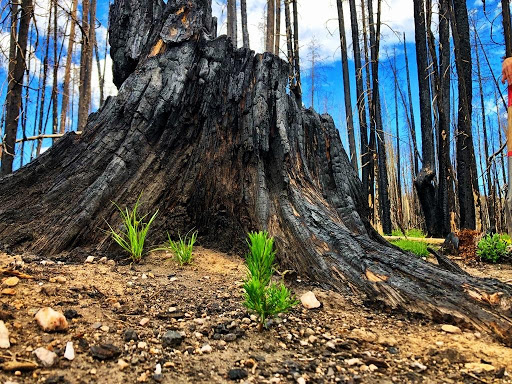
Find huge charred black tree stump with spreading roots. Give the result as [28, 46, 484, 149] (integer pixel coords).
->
[0, 0, 512, 344]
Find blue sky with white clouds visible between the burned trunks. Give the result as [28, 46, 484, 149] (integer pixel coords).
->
[0, 0, 505, 194]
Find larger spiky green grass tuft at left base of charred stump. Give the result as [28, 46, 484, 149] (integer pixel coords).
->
[107, 196, 158, 262]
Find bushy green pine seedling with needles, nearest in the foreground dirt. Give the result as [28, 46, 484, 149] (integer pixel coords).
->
[243, 232, 298, 331]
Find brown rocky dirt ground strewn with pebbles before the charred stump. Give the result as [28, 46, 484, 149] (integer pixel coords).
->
[0, 249, 512, 383]
